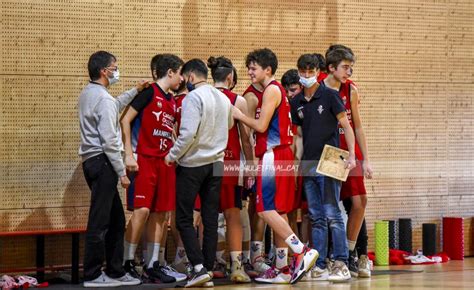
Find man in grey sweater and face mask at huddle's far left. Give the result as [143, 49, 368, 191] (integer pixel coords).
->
[78, 51, 148, 287]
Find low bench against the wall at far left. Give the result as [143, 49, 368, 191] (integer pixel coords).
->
[0, 229, 86, 284]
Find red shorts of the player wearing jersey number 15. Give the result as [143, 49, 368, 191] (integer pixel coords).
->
[127, 154, 176, 212]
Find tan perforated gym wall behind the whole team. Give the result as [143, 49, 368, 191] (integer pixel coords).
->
[0, 0, 474, 270]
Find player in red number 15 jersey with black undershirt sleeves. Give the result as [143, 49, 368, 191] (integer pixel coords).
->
[121, 54, 186, 283]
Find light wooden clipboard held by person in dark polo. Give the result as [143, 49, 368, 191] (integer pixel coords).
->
[316, 144, 350, 181]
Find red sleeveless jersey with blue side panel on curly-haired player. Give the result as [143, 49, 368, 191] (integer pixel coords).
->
[255, 80, 293, 157]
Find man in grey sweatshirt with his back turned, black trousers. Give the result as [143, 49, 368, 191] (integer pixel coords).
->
[165, 59, 233, 287]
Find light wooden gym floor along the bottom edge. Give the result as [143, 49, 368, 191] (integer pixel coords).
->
[50, 258, 474, 290]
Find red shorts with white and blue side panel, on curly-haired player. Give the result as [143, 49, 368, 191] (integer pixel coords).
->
[256, 146, 295, 213]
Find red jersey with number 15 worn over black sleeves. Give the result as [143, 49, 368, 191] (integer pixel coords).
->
[137, 83, 176, 157]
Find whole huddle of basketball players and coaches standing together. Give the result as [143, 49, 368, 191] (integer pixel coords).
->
[79, 45, 372, 287]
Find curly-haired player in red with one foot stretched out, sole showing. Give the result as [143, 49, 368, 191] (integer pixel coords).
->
[233, 48, 318, 283]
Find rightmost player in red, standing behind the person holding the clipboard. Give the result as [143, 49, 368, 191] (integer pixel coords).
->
[324, 45, 372, 278]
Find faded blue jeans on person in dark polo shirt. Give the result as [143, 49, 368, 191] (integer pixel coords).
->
[303, 175, 349, 269]
